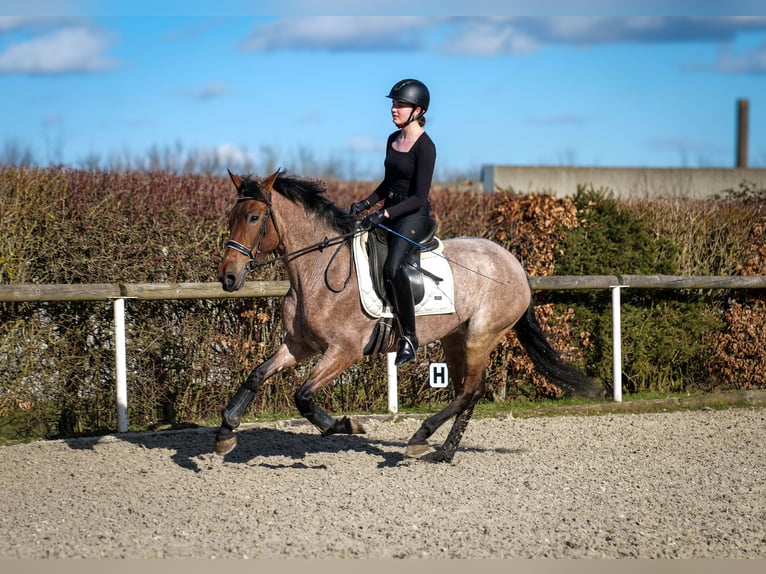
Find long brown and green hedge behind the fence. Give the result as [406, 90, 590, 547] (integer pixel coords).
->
[0, 167, 766, 440]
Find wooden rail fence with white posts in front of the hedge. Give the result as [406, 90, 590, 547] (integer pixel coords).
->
[0, 275, 766, 432]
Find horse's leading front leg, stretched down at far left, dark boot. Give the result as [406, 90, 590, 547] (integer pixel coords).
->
[215, 341, 310, 454]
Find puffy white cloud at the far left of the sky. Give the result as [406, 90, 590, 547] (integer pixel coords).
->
[0, 26, 119, 74]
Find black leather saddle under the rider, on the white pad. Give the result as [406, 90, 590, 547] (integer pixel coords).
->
[365, 219, 444, 305]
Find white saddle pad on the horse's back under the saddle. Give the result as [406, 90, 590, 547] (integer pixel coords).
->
[354, 231, 455, 317]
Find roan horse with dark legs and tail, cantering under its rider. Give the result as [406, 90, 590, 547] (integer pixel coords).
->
[215, 170, 600, 462]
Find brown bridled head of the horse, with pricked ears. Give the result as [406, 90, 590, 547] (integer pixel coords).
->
[218, 170, 281, 291]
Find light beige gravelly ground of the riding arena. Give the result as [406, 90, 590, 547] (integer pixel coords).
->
[0, 408, 766, 558]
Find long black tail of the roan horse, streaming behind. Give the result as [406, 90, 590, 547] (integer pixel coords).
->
[514, 299, 603, 398]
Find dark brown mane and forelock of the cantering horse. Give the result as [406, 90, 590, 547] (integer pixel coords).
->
[242, 172, 356, 233]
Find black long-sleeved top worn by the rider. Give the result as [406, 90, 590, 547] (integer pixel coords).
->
[367, 131, 436, 219]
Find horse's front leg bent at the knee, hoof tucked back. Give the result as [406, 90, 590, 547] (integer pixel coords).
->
[295, 350, 366, 436]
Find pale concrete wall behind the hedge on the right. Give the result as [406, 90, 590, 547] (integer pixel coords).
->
[481, 165, 766, 199]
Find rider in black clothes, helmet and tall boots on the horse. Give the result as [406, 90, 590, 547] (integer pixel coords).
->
[350, 79, 436, 365]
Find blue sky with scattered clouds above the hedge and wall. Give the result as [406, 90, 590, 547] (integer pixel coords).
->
[0, 4, 766, 180]
